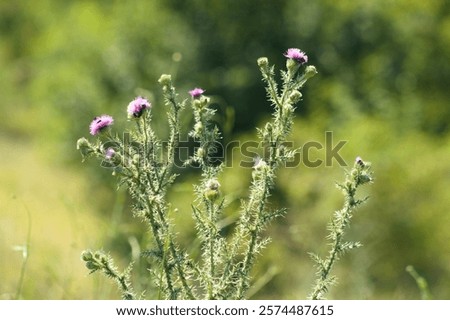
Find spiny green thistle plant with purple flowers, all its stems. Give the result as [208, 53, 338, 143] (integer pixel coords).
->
[77, 49, 370, 299]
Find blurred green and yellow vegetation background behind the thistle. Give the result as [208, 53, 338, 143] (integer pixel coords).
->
[0, 0, 450, 299]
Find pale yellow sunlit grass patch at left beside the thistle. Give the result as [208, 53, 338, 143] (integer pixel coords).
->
[0, 137, 116, 299]
